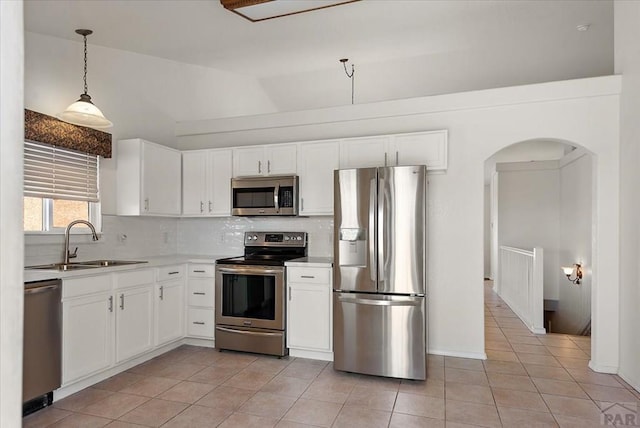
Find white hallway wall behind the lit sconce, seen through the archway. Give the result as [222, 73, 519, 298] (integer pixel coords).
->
[552, 153, 596, 334]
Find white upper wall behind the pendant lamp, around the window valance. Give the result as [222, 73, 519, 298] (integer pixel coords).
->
[25, 29, 275, 214]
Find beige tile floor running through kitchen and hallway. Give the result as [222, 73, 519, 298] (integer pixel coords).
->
[23, 285, 640, 428]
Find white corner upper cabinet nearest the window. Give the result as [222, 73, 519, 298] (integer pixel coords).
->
[116, 139, 181, 216]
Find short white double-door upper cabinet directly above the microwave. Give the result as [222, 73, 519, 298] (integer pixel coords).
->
[233, 144, 297, 177]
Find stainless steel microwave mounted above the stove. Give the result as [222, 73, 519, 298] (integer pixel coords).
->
[231, 175, 298, 216]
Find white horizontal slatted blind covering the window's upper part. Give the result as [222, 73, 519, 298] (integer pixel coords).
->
[24, 141, 98, 202]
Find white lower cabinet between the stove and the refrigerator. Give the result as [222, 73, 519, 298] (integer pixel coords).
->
[287, 267, 333, 360]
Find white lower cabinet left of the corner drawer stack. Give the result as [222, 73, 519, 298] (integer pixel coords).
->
[155, 265, 185, 345]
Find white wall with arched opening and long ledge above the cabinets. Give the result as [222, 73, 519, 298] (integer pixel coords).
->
[177, 77, 620, 364]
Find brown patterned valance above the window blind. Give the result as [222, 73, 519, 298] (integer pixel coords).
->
[24, 109, 111, 158]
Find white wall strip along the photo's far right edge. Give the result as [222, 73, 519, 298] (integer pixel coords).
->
[615, 0, 640, 390]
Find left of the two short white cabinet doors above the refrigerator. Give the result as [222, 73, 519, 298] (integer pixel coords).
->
[340, 136, 390, 168]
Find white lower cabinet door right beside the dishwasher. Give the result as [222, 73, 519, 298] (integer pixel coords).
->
[62, 293, 115, 385]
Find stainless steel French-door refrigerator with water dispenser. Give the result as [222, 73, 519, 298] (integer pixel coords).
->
[333, 166, 427, 379]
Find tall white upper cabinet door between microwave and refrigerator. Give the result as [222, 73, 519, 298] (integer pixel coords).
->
[298, 141, 340, 215]
